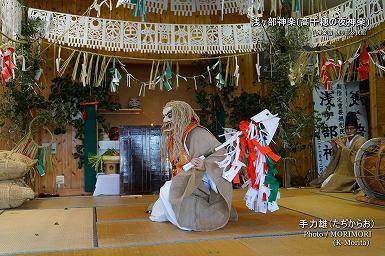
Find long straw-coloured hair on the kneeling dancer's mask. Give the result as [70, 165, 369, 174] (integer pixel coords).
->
[161, 101, 200, 160]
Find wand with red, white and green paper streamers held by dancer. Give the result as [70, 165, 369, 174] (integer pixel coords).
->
[183, 109, 280, 213]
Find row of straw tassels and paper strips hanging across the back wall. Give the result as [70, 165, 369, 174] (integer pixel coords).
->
[55, 47, 239, 96]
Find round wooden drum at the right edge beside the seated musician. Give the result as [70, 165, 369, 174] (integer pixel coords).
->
[354, 138, 385, 199]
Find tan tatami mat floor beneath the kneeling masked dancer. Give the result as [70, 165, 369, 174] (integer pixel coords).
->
[0, 188, 385, 256]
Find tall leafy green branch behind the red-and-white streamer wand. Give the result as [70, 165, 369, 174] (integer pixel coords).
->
[255, 26, 317, 157]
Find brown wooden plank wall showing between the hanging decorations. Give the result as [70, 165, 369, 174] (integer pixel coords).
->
[5, 0, 380, 195]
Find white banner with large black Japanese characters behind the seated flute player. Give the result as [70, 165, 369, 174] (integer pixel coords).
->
[313, 80, 368, 174]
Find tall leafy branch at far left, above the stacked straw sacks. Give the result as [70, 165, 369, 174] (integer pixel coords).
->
[0, 14, 46, 140]
